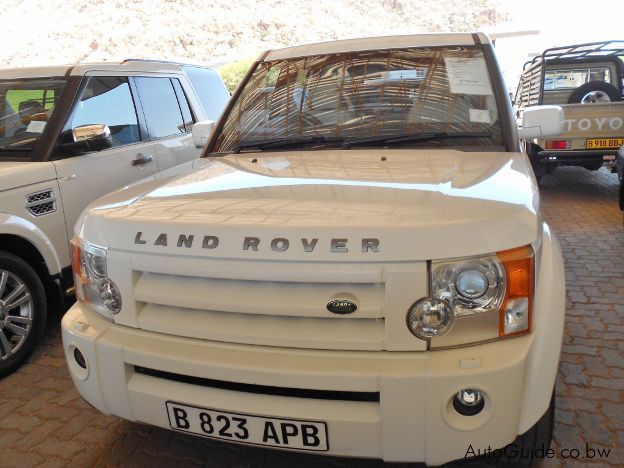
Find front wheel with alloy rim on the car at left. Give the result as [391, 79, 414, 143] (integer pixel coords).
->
[0, 251, 47, 378]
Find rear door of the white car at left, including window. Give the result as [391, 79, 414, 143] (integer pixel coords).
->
[134, 76, 201, 171]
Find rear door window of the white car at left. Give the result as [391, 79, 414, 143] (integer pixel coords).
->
[135, 77, 187, 138]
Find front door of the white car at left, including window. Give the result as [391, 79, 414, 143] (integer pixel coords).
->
[54, 76, 158, 237]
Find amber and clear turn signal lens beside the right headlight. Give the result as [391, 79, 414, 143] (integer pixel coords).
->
[497, 245, 535, 337]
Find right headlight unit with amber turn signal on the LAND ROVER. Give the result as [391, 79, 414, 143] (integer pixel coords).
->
[407, 246, 535, 348]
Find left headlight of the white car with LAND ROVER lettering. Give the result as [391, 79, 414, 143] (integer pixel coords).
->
[71, 238, 121, 319]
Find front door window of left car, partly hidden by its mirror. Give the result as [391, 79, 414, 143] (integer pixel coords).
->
[71, 76, 141, 147]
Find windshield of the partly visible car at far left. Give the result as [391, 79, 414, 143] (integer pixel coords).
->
[0, 78, 66, 157]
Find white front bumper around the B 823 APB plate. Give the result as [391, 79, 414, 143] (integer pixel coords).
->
[63, 303, 544, 464]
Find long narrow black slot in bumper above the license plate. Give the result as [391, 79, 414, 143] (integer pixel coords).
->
[134, 366, 379, 403]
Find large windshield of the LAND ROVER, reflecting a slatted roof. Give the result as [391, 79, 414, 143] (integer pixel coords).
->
[213, 46, 504, 152]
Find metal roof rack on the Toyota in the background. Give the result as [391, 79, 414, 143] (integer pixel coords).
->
[514, 40, 624, 107]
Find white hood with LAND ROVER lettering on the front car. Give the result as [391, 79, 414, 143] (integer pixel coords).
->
[76, 149, 541, 261]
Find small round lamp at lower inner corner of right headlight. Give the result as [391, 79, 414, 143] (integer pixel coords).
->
[407, 298, 453, 340]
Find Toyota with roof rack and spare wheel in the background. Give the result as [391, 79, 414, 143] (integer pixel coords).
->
[515, 41, 624, 178]
